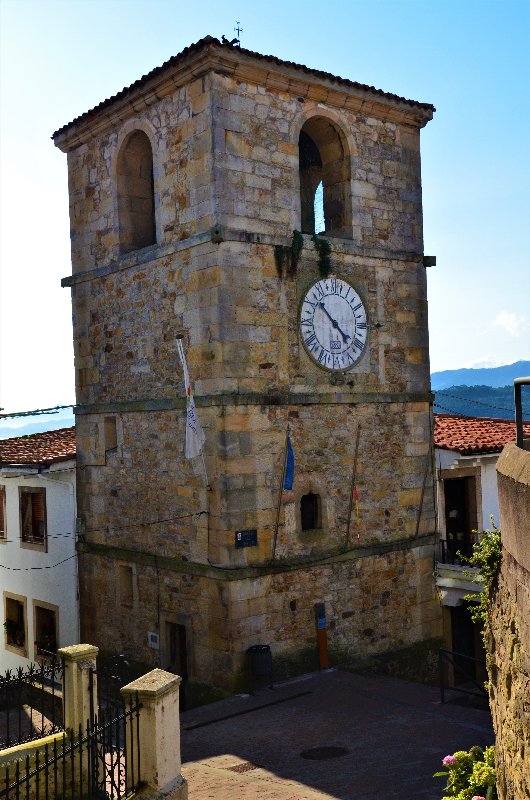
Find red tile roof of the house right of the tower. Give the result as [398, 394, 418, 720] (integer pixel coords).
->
[434, 414, 530, 456]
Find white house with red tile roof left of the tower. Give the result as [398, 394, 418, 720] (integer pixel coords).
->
[0, 428, 79, 673]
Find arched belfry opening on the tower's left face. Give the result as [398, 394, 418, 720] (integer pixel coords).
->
[117, 131, 156, 253]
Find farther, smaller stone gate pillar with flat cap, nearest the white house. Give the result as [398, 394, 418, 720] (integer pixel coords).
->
[57, 644, 99, 733]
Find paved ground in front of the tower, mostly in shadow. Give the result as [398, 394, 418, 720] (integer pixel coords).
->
[181, 670, 493, 800]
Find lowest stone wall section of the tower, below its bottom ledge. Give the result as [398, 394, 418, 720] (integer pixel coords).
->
[80, 538, 440, 689]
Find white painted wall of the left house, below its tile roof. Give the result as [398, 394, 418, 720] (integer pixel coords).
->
[0, 459, 79, 674]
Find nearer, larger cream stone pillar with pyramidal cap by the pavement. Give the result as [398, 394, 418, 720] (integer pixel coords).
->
[120, 669, 188, 800]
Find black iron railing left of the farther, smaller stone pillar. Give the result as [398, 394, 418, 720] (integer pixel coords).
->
[0, 657, 64, 749]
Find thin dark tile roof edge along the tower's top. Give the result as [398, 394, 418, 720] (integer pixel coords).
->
[52, 36, 436, 139]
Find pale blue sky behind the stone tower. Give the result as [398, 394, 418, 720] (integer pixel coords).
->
[0, 0, 530, 411]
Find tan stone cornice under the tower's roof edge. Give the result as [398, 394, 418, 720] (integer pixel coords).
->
[52, 45, 433, 153]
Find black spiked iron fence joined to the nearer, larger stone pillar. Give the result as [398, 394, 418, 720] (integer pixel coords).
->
[0, 697, 141, 800]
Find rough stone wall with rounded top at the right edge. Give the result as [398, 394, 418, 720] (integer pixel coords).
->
[487, 444, 530, 800]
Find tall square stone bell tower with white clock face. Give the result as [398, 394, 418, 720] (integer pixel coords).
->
[53, 37, 440, 687]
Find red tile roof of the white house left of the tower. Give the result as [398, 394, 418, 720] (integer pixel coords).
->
[0, 427, 76, 467]
